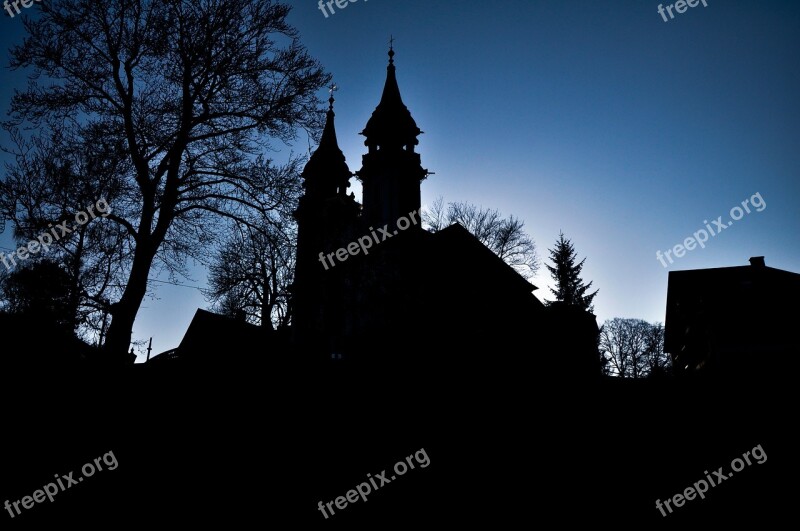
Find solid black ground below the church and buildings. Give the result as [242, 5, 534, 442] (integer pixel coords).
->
[0, 354, 797, 529]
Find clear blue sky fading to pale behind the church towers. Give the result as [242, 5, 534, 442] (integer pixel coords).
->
[0, 0, 800, 362]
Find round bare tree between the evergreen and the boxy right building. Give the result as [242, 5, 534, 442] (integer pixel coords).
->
[600, 317, 669, 378]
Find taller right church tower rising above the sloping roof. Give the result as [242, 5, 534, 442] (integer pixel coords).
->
[356, 46, 428, 228]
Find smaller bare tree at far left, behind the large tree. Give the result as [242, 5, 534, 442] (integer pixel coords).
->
[0, 128, 130, 341]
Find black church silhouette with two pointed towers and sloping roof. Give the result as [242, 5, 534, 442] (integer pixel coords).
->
[291, 48, 599, 374]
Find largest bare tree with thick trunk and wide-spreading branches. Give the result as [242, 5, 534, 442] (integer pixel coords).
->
[6, 0, 329, 357]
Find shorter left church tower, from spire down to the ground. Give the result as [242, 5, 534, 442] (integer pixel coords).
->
[292, 87, 360, 351]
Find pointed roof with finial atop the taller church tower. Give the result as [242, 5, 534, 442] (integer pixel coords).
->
[361, 46, 422, 147]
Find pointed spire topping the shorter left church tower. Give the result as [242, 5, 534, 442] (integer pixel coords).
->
[303, 85, 352, 197]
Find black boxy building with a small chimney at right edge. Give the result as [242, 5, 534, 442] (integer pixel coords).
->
[664, 256, 800, 376]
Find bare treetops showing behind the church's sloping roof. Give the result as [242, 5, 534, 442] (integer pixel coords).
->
[422, 197, 539, 278]
